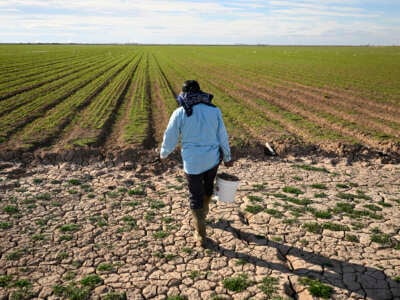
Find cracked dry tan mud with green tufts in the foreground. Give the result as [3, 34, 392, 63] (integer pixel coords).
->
[0, 157, 400, 299]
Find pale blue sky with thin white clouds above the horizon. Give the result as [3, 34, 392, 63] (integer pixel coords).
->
[0, 0, 400, 45]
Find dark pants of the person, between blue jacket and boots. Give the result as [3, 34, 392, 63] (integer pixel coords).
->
[186, 164, 219, 209]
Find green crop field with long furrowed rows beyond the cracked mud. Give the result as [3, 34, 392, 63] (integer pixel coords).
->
[0, 45, 400, 159]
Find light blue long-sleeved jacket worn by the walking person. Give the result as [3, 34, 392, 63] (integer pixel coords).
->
[160, 103, 231, 174]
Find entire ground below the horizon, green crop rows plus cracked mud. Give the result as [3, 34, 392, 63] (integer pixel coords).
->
[0, 45, 400, 300]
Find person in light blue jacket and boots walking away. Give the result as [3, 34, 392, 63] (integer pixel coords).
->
[160, 80, 233, 247]
